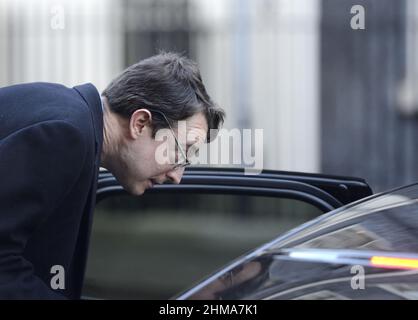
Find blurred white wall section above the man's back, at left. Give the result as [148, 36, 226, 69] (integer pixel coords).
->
[0, 0, 123, 90]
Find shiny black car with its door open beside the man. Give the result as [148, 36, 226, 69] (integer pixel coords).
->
[84, 168, 418, 299]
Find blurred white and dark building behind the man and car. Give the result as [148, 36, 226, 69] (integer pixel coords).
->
[0, 0, 418, 191]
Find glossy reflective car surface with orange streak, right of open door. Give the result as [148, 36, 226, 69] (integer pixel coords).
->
[177, 184, 418, 299]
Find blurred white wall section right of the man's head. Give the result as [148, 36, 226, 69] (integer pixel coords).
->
[191, 0, 320, 172]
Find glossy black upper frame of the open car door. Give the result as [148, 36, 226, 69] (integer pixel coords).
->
[96, 167, 373, 213]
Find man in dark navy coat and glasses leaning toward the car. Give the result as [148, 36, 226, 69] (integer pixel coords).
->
[0, 53, 224, 299]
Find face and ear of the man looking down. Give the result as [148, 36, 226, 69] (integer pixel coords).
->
[113, 109, 208, 195]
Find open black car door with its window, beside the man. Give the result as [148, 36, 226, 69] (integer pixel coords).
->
[83, 167, 372, 299]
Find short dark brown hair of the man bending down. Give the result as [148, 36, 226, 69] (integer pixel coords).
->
[102, 52, 225, 141]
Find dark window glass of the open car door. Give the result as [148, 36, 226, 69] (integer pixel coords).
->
[83, 193, 322, 299]
